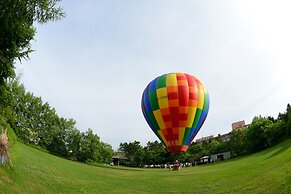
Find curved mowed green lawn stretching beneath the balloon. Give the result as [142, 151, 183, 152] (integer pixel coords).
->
[0, 139, 291, 193]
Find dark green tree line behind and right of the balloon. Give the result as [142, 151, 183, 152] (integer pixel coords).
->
[117, 104, 291, 167]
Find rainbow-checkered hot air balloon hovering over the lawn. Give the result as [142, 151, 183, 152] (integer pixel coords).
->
[141, 73, 209, 152]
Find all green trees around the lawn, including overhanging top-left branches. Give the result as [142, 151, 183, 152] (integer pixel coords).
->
[0, 0, 291, 166]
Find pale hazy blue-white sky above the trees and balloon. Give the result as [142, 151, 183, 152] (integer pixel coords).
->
[16, 0, 291, 149]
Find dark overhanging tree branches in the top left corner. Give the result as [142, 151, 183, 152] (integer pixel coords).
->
[0, 0, 64, 85]
